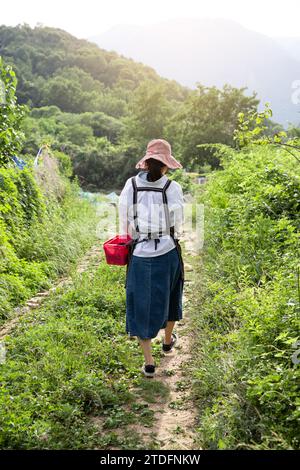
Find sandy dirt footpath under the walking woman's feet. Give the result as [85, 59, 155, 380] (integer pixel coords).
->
[110, 235, 199, 450]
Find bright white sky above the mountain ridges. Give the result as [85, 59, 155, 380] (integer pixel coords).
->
[0, 0, 300, 38]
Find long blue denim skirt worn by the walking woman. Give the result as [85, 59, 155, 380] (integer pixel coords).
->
[126, 248, 183, 339]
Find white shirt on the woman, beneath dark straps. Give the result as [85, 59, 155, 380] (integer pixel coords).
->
[119, 171, 184, 257]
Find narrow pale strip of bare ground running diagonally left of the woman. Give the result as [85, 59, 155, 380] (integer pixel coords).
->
[0, 243, 102, 341]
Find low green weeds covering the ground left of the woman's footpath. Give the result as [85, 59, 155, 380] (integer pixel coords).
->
[0, 262, 162, 449]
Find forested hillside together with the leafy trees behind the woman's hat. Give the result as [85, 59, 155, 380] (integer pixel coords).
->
[0, 25, 273, 190]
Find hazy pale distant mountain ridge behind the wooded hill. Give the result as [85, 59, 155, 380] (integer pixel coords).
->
[89, 18, 300, 125]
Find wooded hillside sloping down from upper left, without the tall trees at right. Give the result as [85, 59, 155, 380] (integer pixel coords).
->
[0, 25, 188, 189]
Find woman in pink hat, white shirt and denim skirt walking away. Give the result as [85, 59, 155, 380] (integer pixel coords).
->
[119, 139, 184, 377]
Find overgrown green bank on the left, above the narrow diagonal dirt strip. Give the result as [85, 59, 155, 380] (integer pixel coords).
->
[0, 155, 96, 323]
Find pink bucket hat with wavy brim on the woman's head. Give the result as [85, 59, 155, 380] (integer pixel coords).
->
[135, 139, 182, 170]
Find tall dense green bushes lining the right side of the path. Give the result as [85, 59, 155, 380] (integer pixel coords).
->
[194, 144, 300, 449]
